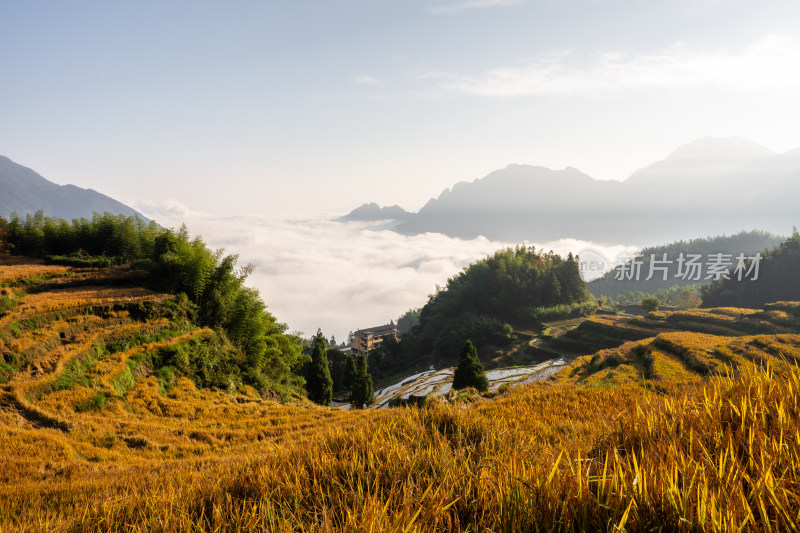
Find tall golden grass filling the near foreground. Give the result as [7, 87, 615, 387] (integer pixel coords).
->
[0, 360, 800, 531]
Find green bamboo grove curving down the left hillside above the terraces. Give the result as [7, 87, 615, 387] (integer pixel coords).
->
[0, 212, 305, 395]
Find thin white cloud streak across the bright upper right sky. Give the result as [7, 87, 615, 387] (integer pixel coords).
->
[422, 35, 800, 97]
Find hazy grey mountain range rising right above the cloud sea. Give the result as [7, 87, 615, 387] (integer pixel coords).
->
[352, 138, 800, 245]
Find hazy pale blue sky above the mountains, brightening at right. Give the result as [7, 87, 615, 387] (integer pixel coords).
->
[0, 0, 800, 215]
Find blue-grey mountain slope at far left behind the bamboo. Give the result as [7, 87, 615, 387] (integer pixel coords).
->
[0, 156, 146, 220]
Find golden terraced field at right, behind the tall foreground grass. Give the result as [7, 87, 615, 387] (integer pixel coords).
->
[554, 302, 800, 383]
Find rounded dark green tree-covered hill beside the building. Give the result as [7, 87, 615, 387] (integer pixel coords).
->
[370, 246, 594, 376]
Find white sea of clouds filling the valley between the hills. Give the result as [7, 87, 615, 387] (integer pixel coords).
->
[136, 202, 631, 341]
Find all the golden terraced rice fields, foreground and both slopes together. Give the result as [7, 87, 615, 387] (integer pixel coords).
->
[0, 259, 800, 532]
